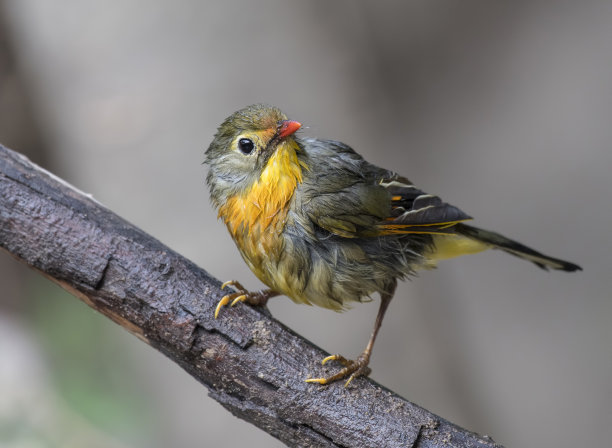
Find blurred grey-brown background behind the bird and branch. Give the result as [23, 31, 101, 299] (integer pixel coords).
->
[0, 0, 612, 448]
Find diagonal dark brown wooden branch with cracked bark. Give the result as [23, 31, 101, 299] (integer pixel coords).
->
[0, 145, 500, 448]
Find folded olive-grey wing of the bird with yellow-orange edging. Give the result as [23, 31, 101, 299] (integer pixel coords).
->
[300, 140, 471, 238]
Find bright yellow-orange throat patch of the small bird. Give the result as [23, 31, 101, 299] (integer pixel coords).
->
[219, 140, 308, 238]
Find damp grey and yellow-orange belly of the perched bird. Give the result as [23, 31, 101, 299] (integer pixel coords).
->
[230, 224, 426, 311]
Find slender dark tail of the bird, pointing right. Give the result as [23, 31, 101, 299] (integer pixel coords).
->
[453, 223, 582, 272]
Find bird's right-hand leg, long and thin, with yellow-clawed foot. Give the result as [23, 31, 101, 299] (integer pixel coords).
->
[306, 285, 395, 387]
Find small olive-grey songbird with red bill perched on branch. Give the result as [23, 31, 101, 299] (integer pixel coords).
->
[205, 105, 581, 385]
